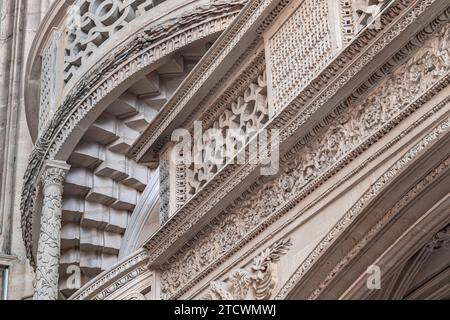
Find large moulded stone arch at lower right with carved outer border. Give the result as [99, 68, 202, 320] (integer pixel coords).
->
[276, 116, 450, 299]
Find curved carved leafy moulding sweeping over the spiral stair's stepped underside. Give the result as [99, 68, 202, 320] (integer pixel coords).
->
[21, 0, 246, 266]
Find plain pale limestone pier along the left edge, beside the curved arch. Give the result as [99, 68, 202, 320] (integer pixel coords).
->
[0, 0, 53, 299]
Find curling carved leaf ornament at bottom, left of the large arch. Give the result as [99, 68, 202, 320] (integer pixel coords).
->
[205, 239, 292, 300]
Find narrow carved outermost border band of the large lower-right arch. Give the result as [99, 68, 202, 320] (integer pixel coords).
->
[276, 118, 450, 299]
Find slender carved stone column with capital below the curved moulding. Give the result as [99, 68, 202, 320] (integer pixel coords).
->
[34, 161, 70, 300]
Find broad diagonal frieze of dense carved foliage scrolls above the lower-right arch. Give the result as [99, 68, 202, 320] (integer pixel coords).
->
[163, 19, 450, 295]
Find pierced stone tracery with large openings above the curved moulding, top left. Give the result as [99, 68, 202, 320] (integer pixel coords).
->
[64, 0, 165, 83]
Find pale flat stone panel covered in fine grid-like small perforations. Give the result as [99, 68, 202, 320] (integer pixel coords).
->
[267, 0, 333, 113]
